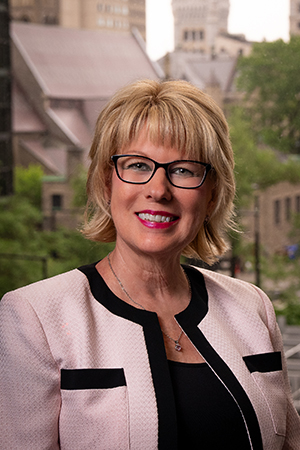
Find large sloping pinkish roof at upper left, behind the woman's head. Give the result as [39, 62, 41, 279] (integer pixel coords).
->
[11, 22, 162, 99]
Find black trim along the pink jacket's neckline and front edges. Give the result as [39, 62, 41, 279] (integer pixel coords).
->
[79, 264, 263, 450]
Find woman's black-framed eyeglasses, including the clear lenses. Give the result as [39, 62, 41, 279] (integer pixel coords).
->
[111, 155, 212, 189]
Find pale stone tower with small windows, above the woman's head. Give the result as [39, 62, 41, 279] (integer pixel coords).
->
[159, 0, 252, 107]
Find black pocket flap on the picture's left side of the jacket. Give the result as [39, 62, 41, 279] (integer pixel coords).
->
[60, 368, 126, 390]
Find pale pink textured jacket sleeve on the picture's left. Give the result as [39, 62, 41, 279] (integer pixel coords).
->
[0, 289, 60, 450]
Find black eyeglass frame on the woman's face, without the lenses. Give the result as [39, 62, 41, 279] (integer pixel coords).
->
[110, 154, 213, 189]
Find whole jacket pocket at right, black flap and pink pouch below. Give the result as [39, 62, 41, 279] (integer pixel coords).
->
[243, 352, 287, 436]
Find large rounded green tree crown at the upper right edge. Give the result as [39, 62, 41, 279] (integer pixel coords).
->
[237, 36, 300, 153]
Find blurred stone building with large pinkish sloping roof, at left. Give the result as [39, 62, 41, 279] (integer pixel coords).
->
[11, 22, 164, 227]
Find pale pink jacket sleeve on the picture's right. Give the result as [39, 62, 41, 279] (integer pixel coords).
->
[256, 288, 300, 450]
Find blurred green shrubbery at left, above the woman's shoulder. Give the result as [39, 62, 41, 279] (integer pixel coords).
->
[0, 167, 113, 298]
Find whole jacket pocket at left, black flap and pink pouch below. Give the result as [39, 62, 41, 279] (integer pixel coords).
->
[59, 368, 129, 450]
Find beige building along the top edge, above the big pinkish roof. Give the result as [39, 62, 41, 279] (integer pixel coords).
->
[10, 0, 146, 40]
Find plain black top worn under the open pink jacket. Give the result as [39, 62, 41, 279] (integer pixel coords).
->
[168, 361, 250, 450]
